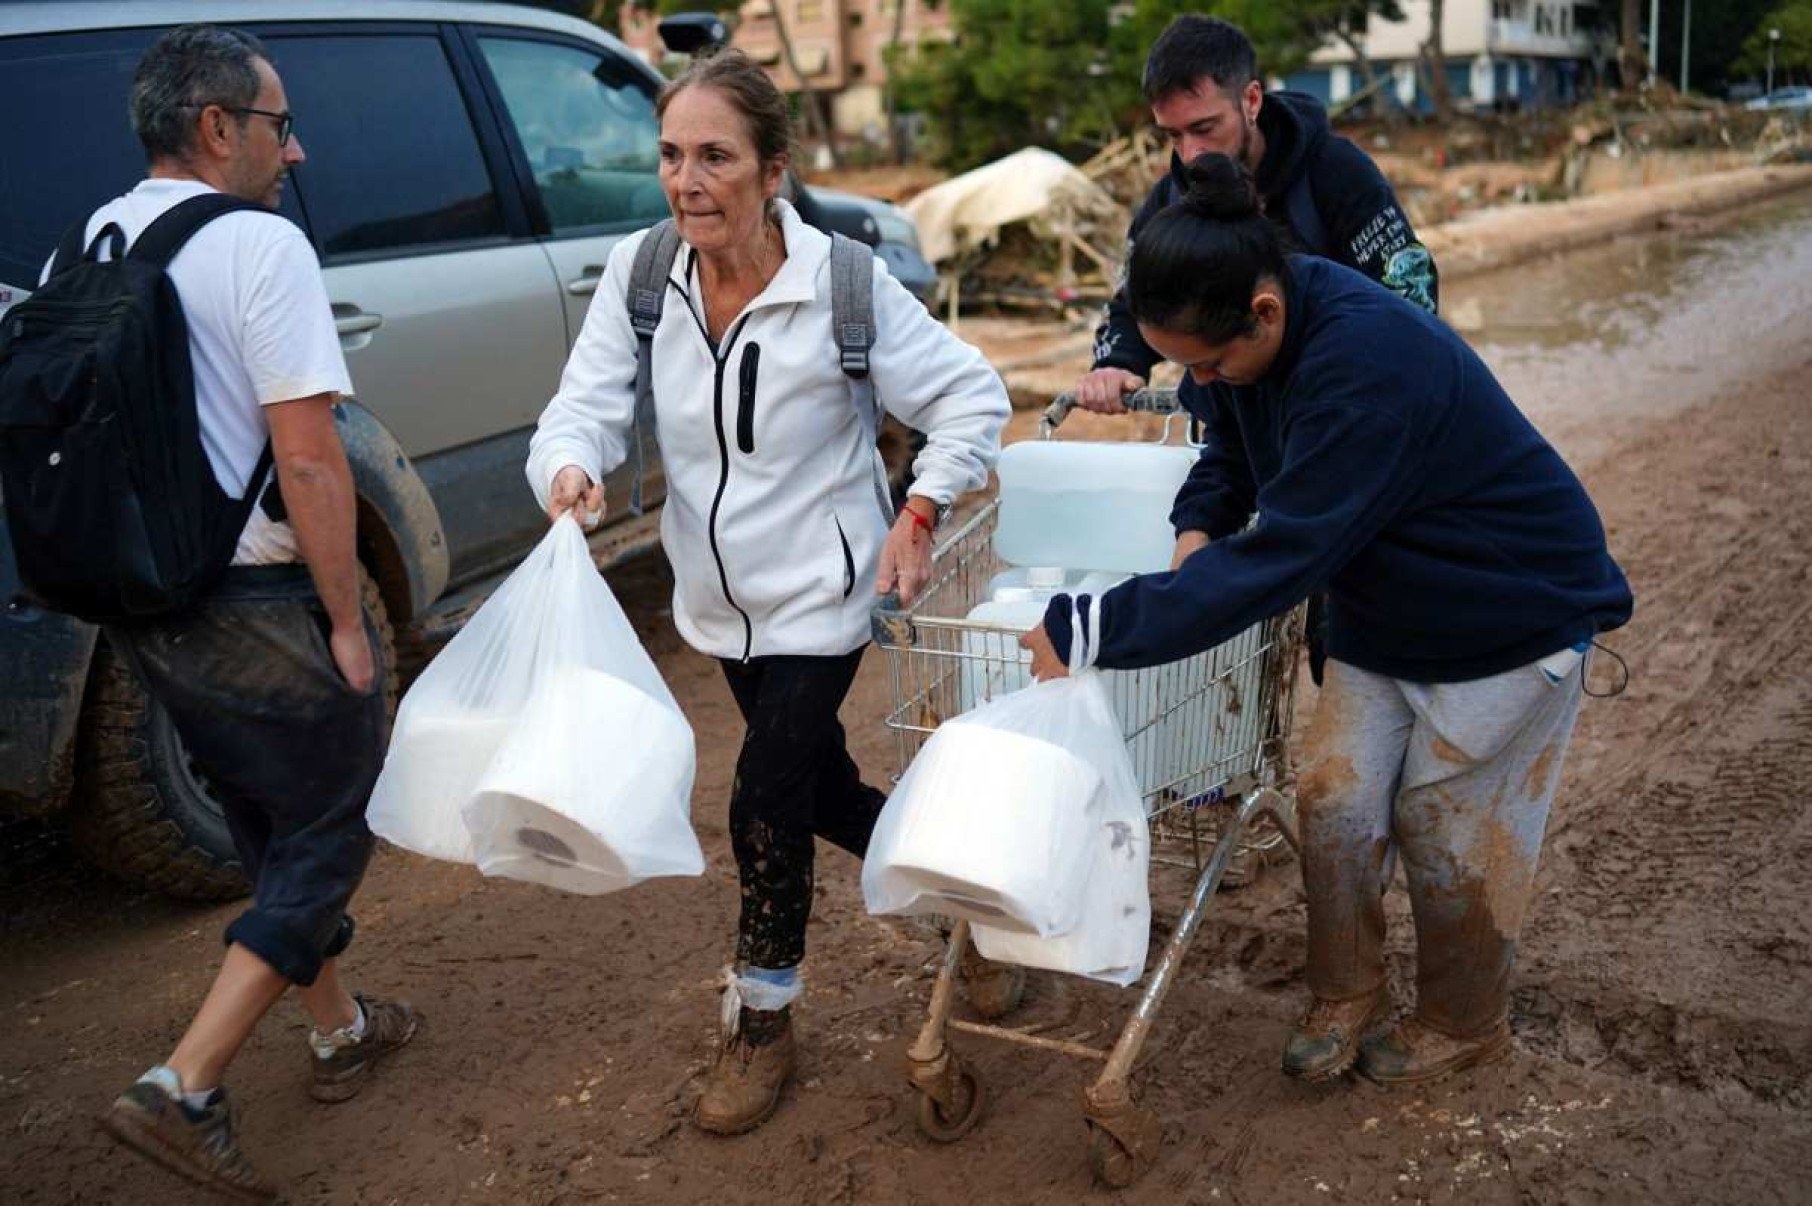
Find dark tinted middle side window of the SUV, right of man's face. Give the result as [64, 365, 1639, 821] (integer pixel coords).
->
[268, 33, 504, 257]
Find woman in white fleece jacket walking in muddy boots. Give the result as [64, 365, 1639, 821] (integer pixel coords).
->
[527, 51, 1007, 1134]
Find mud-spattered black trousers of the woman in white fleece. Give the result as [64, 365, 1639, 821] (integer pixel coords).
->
[723, 648, 886, 969]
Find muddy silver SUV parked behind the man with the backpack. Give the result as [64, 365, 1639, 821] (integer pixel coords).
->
[0, 0, 922, 898]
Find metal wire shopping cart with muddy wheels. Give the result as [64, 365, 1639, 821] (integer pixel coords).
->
[873, 389, 1303, 1188]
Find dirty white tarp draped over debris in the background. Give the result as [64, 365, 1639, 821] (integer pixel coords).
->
[906, 147, 1123, 264]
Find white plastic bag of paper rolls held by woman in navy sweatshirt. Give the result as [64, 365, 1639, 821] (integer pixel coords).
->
[863, 674, 1138, 938]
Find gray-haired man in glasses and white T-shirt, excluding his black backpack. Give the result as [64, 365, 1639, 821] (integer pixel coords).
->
[45, 25, 419, 1201]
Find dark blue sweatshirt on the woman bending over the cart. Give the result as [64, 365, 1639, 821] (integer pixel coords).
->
[1046, 255, 1633, 683]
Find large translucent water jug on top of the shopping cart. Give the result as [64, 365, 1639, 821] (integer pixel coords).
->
[995, 440, 1196, 574]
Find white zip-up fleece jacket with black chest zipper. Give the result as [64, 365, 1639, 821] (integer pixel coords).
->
[527, 201, 1007, 659]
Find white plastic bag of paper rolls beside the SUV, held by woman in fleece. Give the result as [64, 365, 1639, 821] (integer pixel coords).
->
[366, 520, 705, 895]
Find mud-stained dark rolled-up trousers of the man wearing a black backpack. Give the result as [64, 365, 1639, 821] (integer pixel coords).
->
[107, 565, 384, 985]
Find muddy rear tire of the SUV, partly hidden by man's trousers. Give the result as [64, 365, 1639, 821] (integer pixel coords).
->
[67, 570, 397, 900]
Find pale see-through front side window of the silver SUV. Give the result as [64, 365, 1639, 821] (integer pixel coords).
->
[478, 36, 667, 234]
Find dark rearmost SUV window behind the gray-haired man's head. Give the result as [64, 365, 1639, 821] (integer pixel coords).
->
[0, 29, 301, 290]
